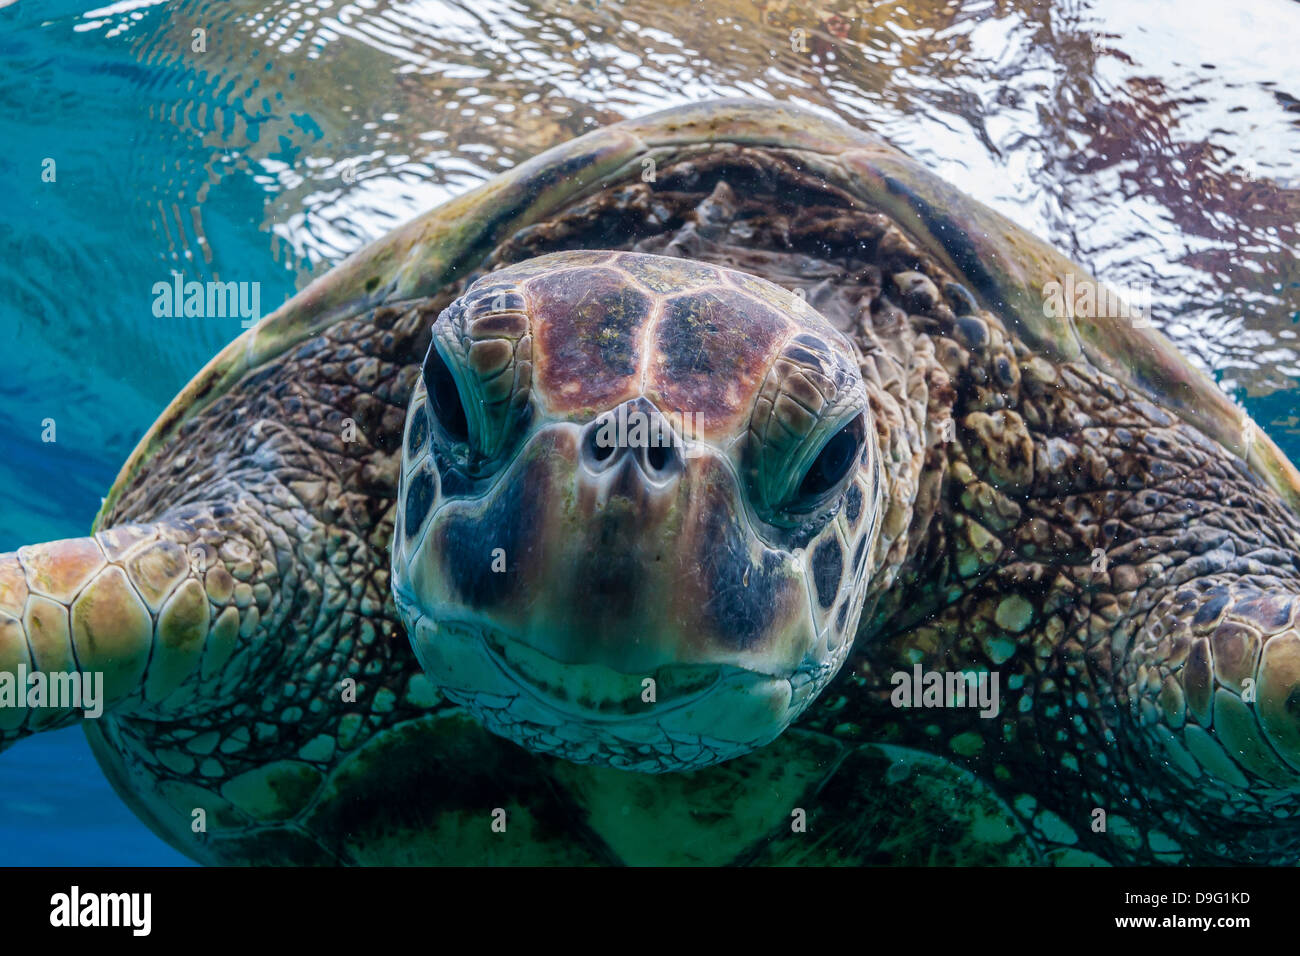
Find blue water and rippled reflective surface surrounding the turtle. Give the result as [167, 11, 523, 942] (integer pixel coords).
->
[0, 0, 1300, 865]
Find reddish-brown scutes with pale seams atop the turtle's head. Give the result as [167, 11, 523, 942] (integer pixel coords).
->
[486, 251, 842, 438]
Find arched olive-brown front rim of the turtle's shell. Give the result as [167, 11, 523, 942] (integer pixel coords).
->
[95, 99, 1300, 527]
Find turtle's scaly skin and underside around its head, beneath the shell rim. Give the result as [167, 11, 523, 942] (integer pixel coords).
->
[0, 130, 1300, 864]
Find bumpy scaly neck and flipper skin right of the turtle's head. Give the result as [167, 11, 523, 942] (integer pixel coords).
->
[802, 270, 1300, 862]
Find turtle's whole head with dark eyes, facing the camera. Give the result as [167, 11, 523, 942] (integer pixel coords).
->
[393, 252, 881, 771]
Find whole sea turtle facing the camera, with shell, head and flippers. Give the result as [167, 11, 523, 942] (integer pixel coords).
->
[0, 100, 1300, 864]
